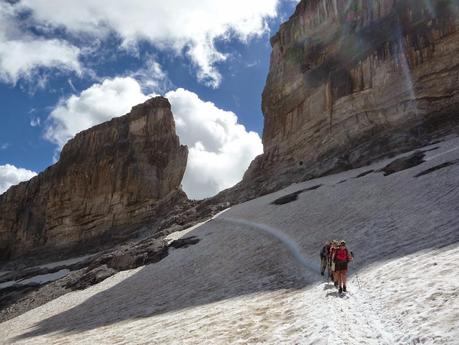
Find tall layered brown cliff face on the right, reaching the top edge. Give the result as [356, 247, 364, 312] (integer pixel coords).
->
[239, 0, 459, 192]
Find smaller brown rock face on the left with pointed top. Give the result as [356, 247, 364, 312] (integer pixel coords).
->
[0, 97, 188, 259]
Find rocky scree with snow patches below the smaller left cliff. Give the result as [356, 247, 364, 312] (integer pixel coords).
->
[0, 204, 228, 322]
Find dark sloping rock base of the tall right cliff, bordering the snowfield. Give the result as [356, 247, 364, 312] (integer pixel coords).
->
[222, 109, 459, 204]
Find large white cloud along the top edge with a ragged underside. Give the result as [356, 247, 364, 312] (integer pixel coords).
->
[17, 0, 285, 87]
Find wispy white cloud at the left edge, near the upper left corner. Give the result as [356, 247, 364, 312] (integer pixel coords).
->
[0, 2, 81, 84]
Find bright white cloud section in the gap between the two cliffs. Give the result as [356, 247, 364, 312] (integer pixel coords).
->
[166, 89, 263, 199]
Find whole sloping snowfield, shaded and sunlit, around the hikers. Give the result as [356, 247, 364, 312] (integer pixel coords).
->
[0, 138, 459, 345]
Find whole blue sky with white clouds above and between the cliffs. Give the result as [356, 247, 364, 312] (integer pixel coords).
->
[0, 0, 298, 199]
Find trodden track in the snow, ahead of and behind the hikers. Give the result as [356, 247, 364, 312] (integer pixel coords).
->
[218, 217, 403, 345]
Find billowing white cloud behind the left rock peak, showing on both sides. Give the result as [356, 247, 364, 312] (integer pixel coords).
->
[46, 77, 263, 199]
